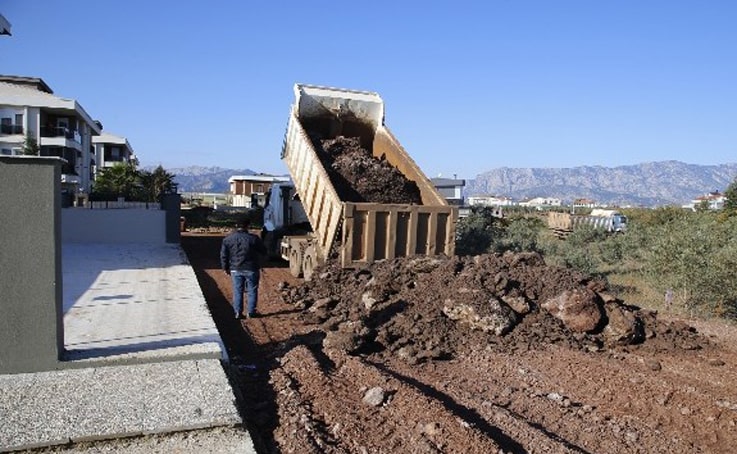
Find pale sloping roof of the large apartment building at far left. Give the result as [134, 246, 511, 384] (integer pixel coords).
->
[0, 76, 101, 134]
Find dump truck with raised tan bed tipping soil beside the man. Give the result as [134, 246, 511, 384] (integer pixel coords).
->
[263, 84, 458, 280]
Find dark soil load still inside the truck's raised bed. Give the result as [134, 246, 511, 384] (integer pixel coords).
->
[313, 136, 422, 205]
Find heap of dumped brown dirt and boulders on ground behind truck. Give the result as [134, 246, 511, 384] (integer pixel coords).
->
[282, 253, 705, 364]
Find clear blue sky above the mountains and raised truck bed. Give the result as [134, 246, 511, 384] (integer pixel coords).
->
[0, 0, 737, 178]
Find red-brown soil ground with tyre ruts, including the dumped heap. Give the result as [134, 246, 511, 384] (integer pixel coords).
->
[182, 234, 737, 453]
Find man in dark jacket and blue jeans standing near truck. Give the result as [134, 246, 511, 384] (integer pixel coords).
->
[220, 217, 266, 319]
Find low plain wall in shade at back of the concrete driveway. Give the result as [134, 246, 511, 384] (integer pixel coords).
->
[61, 208, 166, 243]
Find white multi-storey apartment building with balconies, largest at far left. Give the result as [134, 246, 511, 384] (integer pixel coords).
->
[0, 75, 102, 198]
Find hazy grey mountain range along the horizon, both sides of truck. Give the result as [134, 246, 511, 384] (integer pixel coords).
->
[167, 161, 737, 206]
